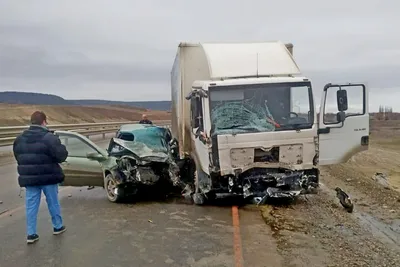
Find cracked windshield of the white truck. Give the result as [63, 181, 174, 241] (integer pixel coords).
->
[209, 82, 314, 135]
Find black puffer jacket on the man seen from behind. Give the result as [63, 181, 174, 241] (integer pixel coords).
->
[13, 125, 68, 187]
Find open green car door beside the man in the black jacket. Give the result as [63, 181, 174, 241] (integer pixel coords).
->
[55, 131, 107, 186]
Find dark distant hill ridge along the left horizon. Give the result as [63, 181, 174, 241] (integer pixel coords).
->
[0, 92, 171, 111]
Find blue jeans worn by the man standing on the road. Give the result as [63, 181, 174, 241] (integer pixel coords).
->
[25, 184, 63, 235]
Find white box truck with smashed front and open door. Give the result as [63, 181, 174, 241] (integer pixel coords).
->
[171, 41, 369, 204]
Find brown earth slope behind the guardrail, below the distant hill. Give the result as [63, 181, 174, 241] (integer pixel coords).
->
[0, 103, 170, 127]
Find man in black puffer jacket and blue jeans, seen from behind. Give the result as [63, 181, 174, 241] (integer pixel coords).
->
[13, 111, 68, 244]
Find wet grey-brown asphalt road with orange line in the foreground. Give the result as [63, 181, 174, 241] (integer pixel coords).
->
[0, 137, 281, 267]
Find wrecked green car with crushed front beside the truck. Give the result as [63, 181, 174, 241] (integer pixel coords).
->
[55, 124, 186, 202]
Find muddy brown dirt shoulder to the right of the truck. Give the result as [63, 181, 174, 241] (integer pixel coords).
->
[261, 121, 400, 266]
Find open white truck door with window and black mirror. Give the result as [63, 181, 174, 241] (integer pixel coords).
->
[318, 84, 369, 165]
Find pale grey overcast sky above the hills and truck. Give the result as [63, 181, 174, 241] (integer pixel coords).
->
[0, 0, 400, 111]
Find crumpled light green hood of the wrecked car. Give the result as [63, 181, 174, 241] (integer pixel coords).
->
[113, 137, 172, 162]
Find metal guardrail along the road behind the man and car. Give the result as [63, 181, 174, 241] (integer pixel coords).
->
[0, 120, 170, 147]
